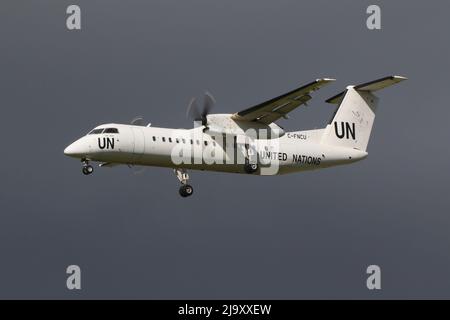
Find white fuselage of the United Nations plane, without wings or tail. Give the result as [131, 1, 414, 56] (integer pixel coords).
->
[64, 124, 367, 175]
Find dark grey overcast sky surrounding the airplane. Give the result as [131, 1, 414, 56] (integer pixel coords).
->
[0, 0, 450, 299]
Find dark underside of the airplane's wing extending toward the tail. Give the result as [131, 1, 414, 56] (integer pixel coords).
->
[232, 78, 335, 124]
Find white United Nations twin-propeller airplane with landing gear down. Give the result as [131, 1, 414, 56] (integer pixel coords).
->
[64, 76, 407, 197]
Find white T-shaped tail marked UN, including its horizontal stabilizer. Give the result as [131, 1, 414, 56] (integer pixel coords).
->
[322, 76, 406, 151]
